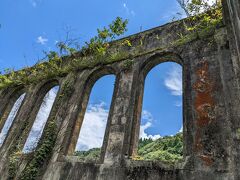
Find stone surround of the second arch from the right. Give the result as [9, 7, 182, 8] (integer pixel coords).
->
[66, 66, 119, 162]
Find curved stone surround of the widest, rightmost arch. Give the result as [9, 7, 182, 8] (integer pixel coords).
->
[129, 53, 186, 160]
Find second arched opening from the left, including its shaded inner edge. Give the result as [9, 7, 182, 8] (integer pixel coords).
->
[22, 80, 59, 153]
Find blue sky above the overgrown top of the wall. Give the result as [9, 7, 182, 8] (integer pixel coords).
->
[0, 0, 185, 70]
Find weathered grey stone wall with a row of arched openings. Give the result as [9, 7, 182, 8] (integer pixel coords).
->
[0, 0, 240, 180]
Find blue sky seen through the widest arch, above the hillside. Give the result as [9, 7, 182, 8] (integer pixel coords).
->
[142, 62, 182, 136]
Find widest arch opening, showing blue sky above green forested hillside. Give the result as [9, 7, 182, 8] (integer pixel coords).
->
[133, 62, 183, 164]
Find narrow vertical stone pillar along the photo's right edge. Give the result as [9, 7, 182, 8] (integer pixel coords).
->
[223, 0, 240, 179]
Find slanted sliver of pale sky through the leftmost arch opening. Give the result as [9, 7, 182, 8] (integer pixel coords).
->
[0, 93, 26, 147]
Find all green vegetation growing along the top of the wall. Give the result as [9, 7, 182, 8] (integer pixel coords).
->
[0, 0, 222, 89]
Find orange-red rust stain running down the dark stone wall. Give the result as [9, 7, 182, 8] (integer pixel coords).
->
[193, 61, 215, 166]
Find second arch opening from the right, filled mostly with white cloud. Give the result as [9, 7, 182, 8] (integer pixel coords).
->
[73, 75, 115, 161]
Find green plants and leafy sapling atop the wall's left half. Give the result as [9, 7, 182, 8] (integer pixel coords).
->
[0, 17, 130, 89]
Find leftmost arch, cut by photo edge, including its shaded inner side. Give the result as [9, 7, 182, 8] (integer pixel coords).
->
[0, 87, 26, 147]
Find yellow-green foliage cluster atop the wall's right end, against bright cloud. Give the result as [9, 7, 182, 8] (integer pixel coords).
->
[177, 0, 223, 43]
